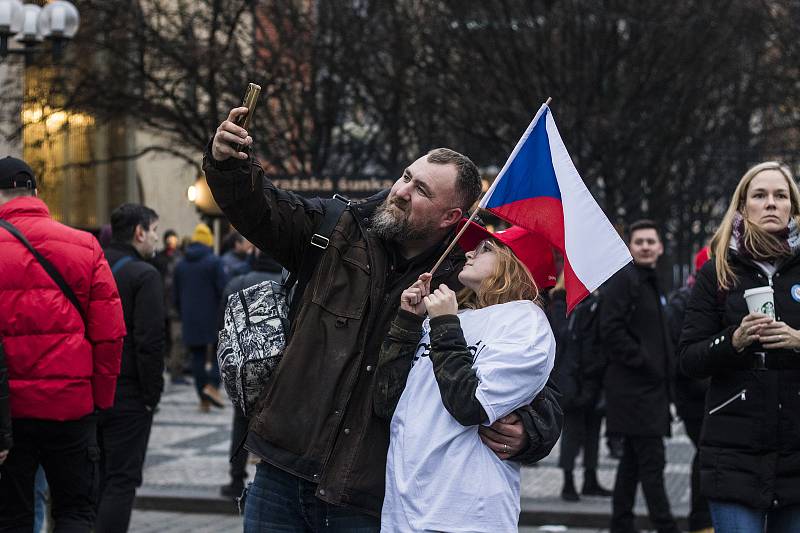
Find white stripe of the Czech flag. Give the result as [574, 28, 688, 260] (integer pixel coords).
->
[534, 106, 633, 292]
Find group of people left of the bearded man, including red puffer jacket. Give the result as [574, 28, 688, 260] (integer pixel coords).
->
[0, 157, 281, 532]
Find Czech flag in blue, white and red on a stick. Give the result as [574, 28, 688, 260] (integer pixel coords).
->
[479, 104, 633, 312]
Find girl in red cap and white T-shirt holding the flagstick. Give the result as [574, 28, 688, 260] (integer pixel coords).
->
[374, 221, 555, 533]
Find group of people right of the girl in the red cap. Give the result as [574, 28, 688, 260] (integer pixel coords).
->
[549, 162, 800, 533]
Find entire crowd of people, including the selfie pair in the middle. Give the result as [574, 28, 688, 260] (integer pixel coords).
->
[0, 103, 800, 533]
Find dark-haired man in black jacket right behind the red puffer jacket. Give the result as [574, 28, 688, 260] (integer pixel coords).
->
[95, 204, 165, 533]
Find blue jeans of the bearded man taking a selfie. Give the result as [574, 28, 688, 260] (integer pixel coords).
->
[244, 462, 381, 533]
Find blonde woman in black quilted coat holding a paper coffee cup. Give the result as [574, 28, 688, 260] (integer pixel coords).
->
[680, 162, 800, 533]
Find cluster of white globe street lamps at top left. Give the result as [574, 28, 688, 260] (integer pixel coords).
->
[0, 0, 80, 61]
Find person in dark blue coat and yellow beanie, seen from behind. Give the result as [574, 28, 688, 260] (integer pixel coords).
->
[173, 224, 227, 412]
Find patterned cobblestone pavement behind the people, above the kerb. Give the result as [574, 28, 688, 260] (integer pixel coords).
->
[138, 384, 693, 531]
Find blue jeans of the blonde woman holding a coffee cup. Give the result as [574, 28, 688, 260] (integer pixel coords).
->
[708, 500, 800, 533]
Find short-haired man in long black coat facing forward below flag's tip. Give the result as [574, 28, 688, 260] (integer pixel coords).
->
[600, 220, 679, 533]
